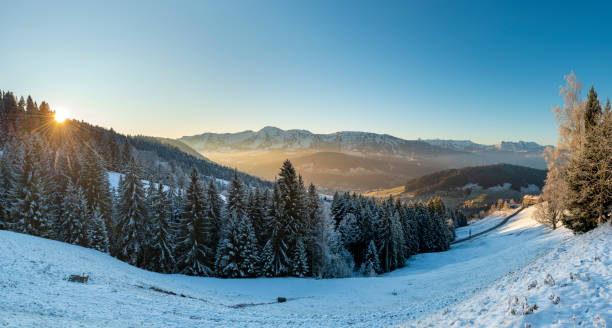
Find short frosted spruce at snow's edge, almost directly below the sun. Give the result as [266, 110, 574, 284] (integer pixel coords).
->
[60, 182, 89, 247]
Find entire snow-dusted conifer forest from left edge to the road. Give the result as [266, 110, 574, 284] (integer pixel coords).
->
[0, 93, 457, 278]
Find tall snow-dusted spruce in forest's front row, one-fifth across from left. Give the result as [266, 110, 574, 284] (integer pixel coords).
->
[114, 160, 149, 265]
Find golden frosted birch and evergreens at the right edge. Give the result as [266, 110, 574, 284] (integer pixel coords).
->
[537, 72, 612, 232]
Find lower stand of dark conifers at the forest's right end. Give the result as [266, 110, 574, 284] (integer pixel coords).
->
[331, 193, 456, 275]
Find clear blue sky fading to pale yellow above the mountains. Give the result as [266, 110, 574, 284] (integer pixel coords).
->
[0, 0, 612, 144]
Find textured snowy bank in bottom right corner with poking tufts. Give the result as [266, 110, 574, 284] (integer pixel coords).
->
[412, 224, 612, 328]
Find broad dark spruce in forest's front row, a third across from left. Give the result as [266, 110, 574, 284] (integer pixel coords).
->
[176, 168, 215, 276]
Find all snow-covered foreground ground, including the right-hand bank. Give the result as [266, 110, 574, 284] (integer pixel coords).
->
[0, 208, 612, 327]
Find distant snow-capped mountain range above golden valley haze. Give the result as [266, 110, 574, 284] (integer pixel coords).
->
[179, 126, 545, 191]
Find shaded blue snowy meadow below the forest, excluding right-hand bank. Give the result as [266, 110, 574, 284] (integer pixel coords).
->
[0, 209, 584, 327]
